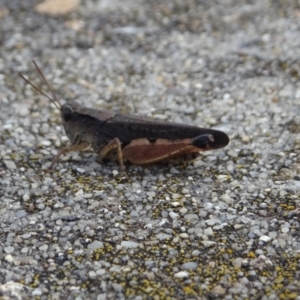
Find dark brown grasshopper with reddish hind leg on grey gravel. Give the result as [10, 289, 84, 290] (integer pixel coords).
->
[19, 61, 229, 171]
